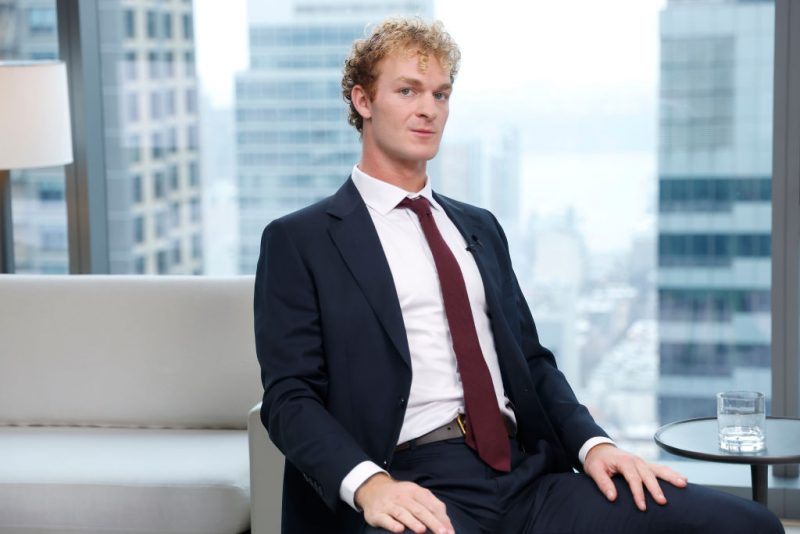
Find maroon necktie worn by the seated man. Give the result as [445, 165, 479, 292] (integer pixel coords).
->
[398, 197, 511, 472]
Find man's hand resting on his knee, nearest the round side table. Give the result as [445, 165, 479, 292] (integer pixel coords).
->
[583, 443, 688, 512]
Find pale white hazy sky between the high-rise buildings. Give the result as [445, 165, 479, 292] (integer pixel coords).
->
[195, 0, 665, 252]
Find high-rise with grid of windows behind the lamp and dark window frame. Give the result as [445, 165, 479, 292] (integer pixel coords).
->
[0, 0, 203, 273]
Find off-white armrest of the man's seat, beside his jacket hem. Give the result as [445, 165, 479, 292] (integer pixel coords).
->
[247, 402, 284, 534]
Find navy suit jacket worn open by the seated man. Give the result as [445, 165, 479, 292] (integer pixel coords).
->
[255, 179, 606, 534]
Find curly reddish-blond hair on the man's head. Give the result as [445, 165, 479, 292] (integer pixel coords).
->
[342, 17, 461, 133]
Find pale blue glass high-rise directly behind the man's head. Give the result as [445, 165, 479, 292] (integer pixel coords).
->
[236, 0, 433, 273]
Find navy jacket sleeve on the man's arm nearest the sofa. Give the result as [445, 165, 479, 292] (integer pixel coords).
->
[254, 220, 369, 509]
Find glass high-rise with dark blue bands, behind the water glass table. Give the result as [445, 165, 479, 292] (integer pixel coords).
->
[658, 0, 775, 422]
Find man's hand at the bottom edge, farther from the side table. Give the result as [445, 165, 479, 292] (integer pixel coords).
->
[354, 473, 455, 534]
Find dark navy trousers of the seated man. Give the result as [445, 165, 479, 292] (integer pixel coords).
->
[364, 439, 784, 534]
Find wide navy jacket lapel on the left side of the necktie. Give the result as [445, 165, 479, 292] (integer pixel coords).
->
[327, 179, 411, 368]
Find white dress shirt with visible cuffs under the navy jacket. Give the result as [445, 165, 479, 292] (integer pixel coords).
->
[339, 165, 611, 509]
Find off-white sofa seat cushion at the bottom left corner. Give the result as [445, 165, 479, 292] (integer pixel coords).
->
[0, 427, 250, 534]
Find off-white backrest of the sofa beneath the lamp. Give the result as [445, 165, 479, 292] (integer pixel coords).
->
[0, 275, 262, 429]
